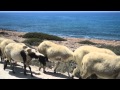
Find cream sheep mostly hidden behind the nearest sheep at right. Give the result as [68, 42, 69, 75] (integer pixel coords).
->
[72, 45, 116, 78]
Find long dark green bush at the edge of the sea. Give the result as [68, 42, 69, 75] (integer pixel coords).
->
[22, 32, 65, 41]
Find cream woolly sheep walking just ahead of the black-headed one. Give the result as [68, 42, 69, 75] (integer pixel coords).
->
[38, 40, 73, 77]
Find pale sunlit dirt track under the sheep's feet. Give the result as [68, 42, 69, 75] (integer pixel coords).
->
[0, 63, 79, 79]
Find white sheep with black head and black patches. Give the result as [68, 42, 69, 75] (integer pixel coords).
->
[4, 43, 46, 76]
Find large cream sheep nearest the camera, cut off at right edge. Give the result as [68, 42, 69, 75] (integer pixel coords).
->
[80, 52, 120, 79]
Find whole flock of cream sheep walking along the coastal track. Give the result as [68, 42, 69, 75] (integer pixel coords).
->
[0, 38, 120, 79]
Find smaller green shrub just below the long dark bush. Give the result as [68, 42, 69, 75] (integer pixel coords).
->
[23, 38, 43, 46]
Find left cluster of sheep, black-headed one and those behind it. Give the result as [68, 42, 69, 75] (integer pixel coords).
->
[0, 38, 47, 76]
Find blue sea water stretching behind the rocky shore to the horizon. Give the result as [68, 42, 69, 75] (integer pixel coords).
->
[0, 11, 120, 40]
